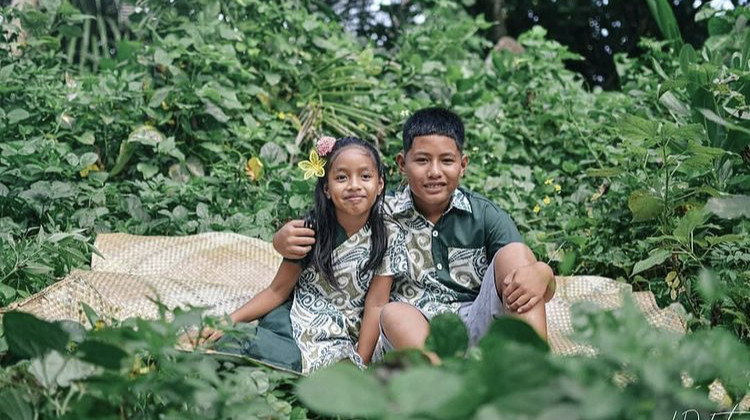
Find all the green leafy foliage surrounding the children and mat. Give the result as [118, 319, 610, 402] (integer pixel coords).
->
[0, 0, 750, 419]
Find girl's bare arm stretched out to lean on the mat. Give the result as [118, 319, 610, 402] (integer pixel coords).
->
[229, 261, 302, 322]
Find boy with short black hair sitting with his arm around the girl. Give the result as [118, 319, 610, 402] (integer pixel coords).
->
[274, 108, 554, 350]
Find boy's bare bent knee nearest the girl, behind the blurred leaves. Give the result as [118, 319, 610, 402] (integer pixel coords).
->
[380, 302, 430, 351]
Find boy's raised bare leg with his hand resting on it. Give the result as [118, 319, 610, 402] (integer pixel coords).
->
[493, 242, 547, 340]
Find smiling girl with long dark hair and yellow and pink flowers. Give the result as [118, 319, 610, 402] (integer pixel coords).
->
[209, 137, 403, 373]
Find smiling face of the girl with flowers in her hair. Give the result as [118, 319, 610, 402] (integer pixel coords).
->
[323, 146, 384, 225]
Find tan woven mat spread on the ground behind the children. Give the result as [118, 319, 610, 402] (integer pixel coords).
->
[2, 232, 685, 354]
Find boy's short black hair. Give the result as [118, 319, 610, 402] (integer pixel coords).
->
[403, 107, 464, 153]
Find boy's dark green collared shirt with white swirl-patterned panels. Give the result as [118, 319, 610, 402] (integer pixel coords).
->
[386, 187, 522, 317]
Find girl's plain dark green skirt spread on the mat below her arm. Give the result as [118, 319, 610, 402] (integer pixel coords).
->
[214, 299, 302, 372]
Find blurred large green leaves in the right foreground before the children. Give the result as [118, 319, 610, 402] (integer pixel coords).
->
[297, 301, 750, 419]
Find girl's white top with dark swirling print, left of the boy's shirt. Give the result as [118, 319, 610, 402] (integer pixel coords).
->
[291, 222, 407, 374]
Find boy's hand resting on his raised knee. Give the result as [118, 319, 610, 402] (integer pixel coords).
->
[503, 262, 555, 314]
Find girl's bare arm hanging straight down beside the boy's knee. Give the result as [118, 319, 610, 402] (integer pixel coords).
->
[357, 276, 393, 363]
